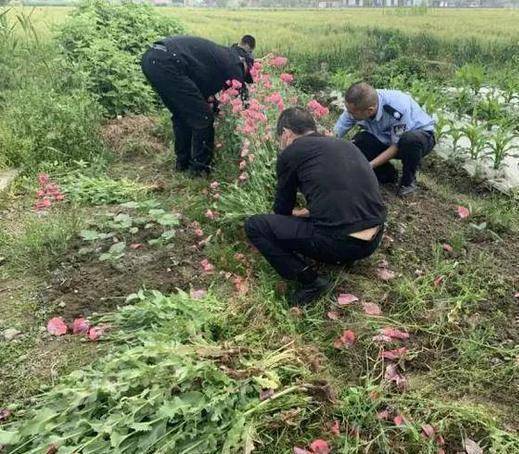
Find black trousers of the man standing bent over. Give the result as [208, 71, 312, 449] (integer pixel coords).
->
[141, 48, 214, 171]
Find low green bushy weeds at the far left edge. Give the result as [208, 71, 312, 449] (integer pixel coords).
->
[0, 85, 103, 169]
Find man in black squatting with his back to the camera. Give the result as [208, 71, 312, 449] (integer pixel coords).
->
[245, 107, 386, 305]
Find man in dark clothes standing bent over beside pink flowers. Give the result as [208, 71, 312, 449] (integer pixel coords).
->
[141, 35, 256, 174]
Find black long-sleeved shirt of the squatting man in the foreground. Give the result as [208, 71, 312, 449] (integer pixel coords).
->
[274, 133, 386, 234]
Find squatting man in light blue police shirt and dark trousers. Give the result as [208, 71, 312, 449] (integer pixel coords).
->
[335, 82, 436, 197]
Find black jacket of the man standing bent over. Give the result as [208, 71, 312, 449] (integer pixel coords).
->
[156, 36, 249, 98]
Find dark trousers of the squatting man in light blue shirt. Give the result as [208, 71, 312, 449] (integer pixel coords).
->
[353, 130, 436, 186]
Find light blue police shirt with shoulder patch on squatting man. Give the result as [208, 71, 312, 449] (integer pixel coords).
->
[334, 90, 435, 146]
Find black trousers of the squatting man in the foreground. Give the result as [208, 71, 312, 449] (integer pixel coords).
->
[245, 214, 383, 280]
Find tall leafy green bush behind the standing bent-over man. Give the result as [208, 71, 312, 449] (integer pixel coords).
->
[58, 0, 184, 116]
